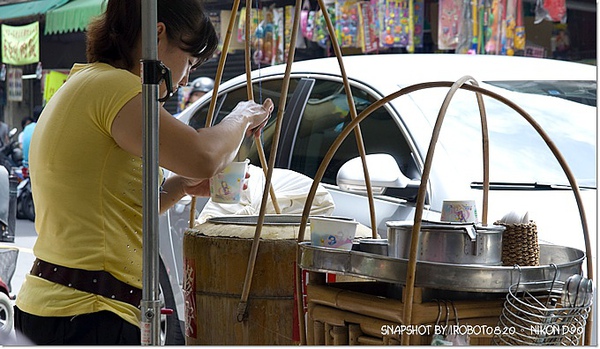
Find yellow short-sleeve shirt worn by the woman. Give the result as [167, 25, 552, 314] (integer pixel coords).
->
[16, 63, 159, 326]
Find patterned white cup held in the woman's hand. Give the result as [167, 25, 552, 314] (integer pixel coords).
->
[210, 159, 250, 204]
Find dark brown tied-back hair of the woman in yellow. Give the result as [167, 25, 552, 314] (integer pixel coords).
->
[86, 0, 218, 70]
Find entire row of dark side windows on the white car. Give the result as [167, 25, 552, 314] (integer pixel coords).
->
[190, 77, 420, 189]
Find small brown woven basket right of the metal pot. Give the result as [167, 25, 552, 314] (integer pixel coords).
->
[494, 221, 540, 266]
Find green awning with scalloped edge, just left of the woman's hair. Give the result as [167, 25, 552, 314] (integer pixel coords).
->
[44, 0, 106, 35]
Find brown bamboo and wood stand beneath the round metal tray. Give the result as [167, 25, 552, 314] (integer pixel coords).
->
[306, 283, 503, 345]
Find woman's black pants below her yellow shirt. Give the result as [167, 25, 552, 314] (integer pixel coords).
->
[15, 306, 141, 345]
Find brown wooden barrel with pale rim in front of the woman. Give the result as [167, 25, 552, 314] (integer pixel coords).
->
[183, 215, 308, 345]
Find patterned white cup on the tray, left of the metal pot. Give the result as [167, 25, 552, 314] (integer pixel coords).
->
[310, 217, 358, 250]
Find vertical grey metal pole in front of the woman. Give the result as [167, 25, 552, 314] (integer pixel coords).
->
[141, 0, 160, 345]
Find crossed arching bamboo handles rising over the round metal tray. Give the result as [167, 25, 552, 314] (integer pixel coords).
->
[296, 77, 593, 344]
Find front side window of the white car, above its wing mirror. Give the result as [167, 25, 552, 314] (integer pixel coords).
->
[291, 80, 420, 184]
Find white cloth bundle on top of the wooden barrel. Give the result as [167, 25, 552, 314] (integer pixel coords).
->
[197, 165, 335, 224]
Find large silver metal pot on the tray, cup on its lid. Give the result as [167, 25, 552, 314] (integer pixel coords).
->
[386, 221, 505, 265]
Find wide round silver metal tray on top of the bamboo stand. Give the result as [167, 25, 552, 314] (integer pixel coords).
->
[300, 242, 585, 293]
